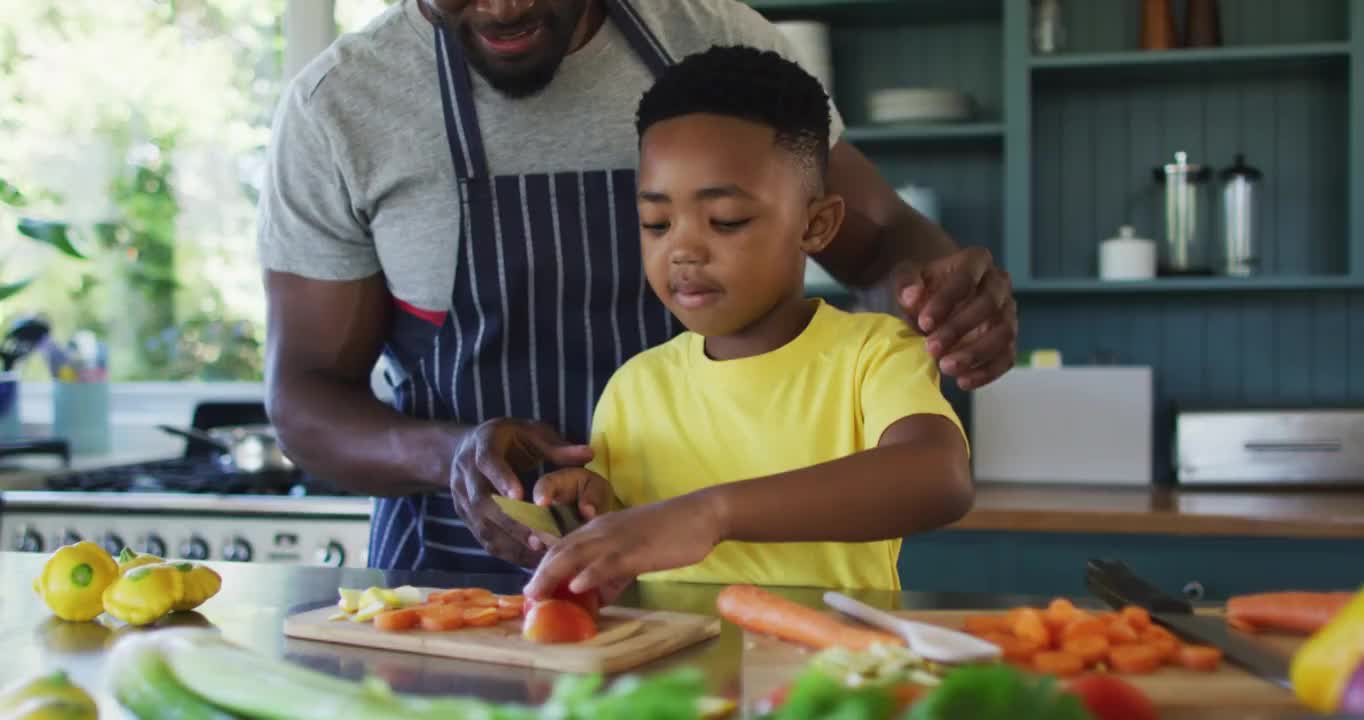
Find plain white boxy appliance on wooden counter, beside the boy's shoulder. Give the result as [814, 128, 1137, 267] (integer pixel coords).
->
[971, 365, 1154, 485]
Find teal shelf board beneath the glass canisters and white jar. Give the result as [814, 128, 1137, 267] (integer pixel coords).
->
[1013, 275, 1364, 295]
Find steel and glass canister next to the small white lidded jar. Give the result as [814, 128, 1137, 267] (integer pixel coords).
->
[1155, 151, 1211, 274]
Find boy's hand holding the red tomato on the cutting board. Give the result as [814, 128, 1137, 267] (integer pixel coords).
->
[525, 494, 723, 600]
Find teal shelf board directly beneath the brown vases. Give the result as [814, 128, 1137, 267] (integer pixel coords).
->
[1030, 42, 1350, 71]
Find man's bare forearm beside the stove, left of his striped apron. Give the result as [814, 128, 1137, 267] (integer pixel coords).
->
[267, 371, 468, 496]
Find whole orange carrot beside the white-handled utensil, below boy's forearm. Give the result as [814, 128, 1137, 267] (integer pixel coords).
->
[715, 585, 904, 650]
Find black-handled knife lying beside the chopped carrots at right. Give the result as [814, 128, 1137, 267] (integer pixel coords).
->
[1084, 559, 1292, 687]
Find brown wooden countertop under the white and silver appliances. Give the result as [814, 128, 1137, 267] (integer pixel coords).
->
[953, 483, 1364, 540]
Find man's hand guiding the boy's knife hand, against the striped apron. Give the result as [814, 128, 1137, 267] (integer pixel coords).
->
[450, 419, 592, 567]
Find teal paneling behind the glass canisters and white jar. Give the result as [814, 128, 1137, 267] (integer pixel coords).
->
[1031, 61, 1349, 278]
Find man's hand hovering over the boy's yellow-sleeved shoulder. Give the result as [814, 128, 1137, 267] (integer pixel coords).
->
[895, 247, 1019, 390]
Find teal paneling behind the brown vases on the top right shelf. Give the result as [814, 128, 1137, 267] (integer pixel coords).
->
[1047, 0, 1349, 52]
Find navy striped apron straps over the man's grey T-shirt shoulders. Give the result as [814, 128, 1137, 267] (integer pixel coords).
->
[432, 0, 672, 180]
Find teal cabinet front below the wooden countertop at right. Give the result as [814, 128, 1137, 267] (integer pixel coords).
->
[900, 530, 1364, 601]
